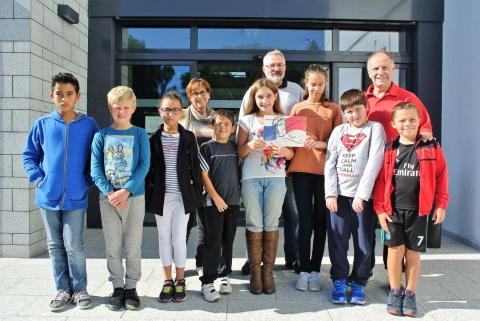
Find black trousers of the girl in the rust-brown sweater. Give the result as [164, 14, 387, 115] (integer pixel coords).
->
[292, 173, 328, 272]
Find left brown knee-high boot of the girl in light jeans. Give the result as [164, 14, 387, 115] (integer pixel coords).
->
[245, 230, 263, 294]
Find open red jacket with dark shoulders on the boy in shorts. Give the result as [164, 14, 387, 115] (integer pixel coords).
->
[373, 137, 449, 216]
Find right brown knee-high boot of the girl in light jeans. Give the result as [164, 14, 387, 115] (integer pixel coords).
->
[262, 230, 278, 294]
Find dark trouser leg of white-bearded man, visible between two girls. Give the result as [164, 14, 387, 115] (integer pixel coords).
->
[282, 177, 298, 263]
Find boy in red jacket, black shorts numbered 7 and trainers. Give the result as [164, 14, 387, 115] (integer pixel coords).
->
[373, 102, 449, 316]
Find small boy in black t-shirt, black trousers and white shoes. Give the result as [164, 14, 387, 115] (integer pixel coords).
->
[200, 110, 240, 302]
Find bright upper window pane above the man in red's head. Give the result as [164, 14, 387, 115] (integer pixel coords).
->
[339, 30, 405, 52]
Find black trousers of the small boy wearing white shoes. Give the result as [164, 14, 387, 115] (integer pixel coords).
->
[200, 205, 239, 284]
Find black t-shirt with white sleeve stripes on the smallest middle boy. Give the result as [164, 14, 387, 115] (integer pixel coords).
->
[200, 140, 240, 206]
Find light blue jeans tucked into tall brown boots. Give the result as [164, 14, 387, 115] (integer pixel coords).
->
[242, 177, 287, 232]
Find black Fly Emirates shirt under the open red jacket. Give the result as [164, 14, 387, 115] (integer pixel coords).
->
[392, 144, 420, 211]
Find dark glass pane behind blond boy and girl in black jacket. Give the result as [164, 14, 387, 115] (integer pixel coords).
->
[121, 65, 190, 133]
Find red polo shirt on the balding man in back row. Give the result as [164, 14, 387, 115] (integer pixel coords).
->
[365, 81, 432, 143]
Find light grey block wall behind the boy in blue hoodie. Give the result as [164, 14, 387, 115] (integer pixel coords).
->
[0, 0, 88, 257]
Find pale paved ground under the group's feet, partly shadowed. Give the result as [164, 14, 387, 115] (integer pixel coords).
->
[0, 227, 480, 321]
